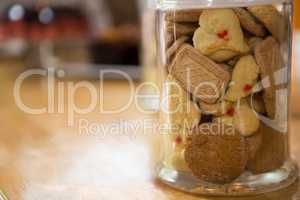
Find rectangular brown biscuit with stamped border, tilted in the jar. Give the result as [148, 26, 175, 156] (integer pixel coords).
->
[169, 44, 230, 103]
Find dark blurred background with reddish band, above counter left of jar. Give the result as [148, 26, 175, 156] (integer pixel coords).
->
[0, 0, 141, 79]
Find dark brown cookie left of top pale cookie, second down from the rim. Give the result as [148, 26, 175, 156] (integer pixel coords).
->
[166, 22, 199, 38]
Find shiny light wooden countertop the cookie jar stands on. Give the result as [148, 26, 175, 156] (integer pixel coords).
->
[0, 70, 300, 200]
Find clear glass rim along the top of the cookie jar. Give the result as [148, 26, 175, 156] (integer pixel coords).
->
[157, 0, 293, 9]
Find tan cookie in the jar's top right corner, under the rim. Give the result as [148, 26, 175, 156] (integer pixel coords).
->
[248, 5, 288, 42]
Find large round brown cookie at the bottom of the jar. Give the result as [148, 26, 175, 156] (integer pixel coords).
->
[185, 123, 248, 184]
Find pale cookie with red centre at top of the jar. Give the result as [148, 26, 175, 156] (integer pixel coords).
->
[193, 9, 249, 62]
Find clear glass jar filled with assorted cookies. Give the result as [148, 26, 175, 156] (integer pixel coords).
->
[157, 0, 298, 196]
